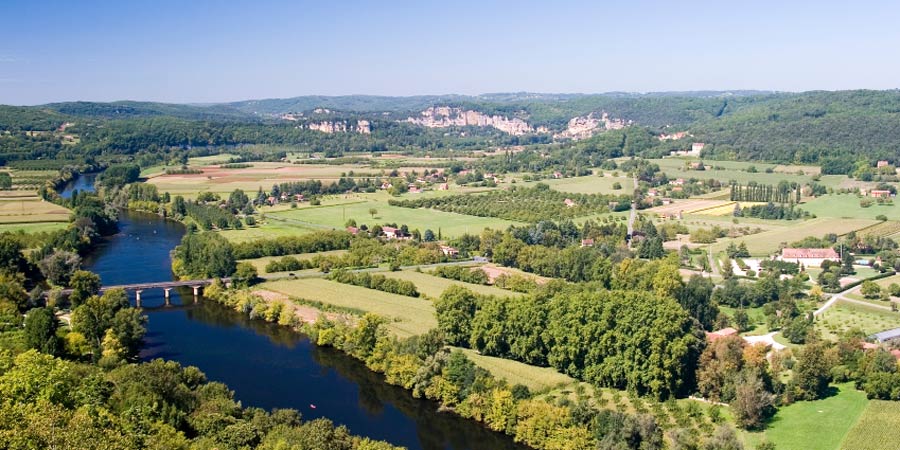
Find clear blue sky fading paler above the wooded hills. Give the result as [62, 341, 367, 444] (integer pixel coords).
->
[0, 0, 900, 105]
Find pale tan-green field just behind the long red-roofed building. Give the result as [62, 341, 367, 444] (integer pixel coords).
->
[713, 218, 876, 256]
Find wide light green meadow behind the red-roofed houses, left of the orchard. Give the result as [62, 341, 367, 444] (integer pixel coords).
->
[267, 201, 521, 238]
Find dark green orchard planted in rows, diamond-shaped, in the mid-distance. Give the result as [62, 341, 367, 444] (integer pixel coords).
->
[389, 185, 631, 222]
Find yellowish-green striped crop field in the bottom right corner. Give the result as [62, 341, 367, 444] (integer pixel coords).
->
[841, 400, 900, 450]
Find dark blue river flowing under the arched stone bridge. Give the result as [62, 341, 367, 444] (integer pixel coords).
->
[85, 212, 522, 450]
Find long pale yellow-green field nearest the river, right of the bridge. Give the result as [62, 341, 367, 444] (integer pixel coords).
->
[260, 278, 437, 337]
